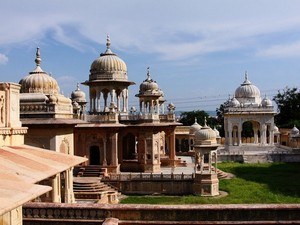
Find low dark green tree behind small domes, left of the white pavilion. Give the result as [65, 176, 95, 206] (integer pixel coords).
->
[179, 110, 211, 126]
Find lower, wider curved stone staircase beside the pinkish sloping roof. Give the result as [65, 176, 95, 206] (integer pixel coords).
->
[73, 177, 119, 204]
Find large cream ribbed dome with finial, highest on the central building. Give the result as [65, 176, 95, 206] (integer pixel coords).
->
[90, 36, 128, 81]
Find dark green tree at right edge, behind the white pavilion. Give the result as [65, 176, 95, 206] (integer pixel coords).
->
[273, 87, 300, 128]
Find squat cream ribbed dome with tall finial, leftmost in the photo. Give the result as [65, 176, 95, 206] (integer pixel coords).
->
[19, 48, 59, 94]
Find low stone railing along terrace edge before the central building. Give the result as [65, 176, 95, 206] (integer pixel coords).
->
[102, 173, 195, 181]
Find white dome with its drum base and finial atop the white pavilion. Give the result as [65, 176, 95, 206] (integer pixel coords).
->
[235, 72, 261, 105]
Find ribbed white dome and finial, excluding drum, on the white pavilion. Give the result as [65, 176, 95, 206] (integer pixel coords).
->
[235, 73, 260, 98]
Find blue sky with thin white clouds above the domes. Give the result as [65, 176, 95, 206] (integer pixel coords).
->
[0, 0, 300, 111]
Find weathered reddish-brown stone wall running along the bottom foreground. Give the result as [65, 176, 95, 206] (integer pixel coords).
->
[23, 203, 300, 225]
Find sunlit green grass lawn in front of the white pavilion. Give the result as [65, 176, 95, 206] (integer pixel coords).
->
[121, 163, 300, 204]
